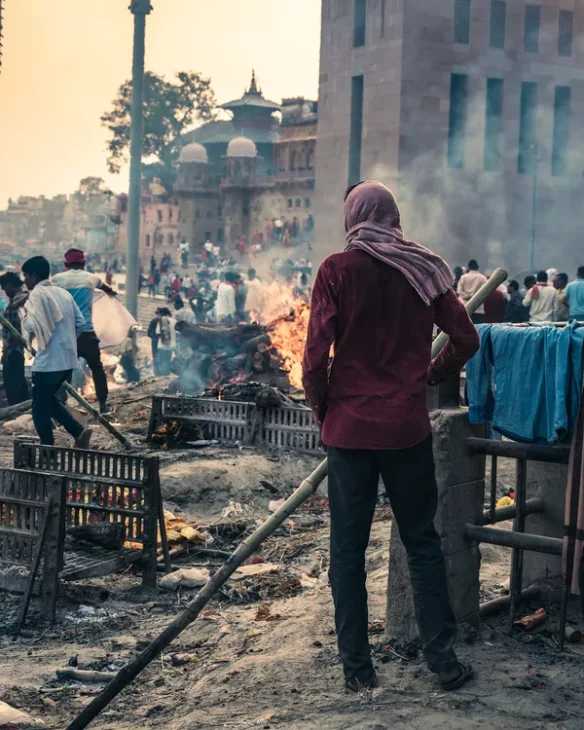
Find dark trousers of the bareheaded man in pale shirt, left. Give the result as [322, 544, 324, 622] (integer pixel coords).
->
[32, 370, 83, 446]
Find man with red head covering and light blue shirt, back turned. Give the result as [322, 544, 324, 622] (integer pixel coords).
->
[53, 248, 116, 414]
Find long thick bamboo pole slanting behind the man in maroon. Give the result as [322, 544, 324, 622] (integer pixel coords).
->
[67, 269, 507, 730]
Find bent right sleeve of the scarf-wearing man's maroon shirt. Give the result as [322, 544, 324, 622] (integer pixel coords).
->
[428, 291, 480, 385]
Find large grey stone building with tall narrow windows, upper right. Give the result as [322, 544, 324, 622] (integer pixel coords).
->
[315, 0, 584, 273]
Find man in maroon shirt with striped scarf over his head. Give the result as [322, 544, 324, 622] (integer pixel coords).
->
[303, 181, 479, 691]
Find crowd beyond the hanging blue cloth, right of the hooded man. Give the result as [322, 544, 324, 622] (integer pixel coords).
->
[454, 259, 584, 324]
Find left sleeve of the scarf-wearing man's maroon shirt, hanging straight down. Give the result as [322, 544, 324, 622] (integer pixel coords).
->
[302, 262, 338, 426]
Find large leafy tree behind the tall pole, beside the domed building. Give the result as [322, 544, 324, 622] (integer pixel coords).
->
[101, 71, 216, 189]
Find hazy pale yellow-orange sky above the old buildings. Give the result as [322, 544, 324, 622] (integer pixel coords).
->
[0, 0, 320, 208]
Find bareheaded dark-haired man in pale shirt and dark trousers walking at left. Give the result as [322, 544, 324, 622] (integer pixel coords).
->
[22, 256, 91, 449]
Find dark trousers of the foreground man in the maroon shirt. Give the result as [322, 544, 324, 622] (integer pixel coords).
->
[328, 436, 457, 680]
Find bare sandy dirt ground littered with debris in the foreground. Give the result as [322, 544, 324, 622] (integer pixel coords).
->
[0, 382, 584, 730]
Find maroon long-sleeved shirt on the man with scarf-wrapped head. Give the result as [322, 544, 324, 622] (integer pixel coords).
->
[303, 250, 479, 449]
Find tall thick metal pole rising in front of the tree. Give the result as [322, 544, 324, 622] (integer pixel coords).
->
[126, 0, 152, 317]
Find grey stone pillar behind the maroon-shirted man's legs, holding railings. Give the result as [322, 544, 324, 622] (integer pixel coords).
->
[386, 396, 485, 641]
